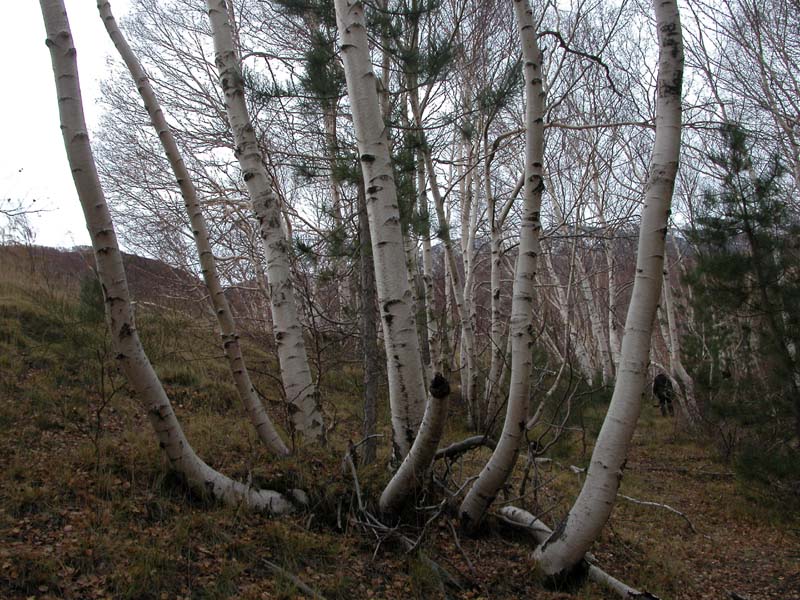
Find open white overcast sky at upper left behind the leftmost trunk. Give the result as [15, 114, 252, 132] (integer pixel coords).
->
[0, 0, 129, 247]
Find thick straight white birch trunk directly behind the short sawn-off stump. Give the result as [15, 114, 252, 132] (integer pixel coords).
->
[335, 0, 426, 458]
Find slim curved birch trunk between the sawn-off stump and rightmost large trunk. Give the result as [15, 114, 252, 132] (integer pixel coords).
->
[460, 0, 545, 531]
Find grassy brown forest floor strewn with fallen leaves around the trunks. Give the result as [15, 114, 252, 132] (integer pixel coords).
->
[0, 246, 800, 600]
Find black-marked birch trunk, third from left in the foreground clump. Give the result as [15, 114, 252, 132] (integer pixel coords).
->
[206, 0, 325, 441]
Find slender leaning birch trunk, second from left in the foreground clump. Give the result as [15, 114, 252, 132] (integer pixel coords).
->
[97, 0, 289, 455]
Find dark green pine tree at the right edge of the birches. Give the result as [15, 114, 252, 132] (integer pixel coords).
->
[687, 123, 800, 437]
